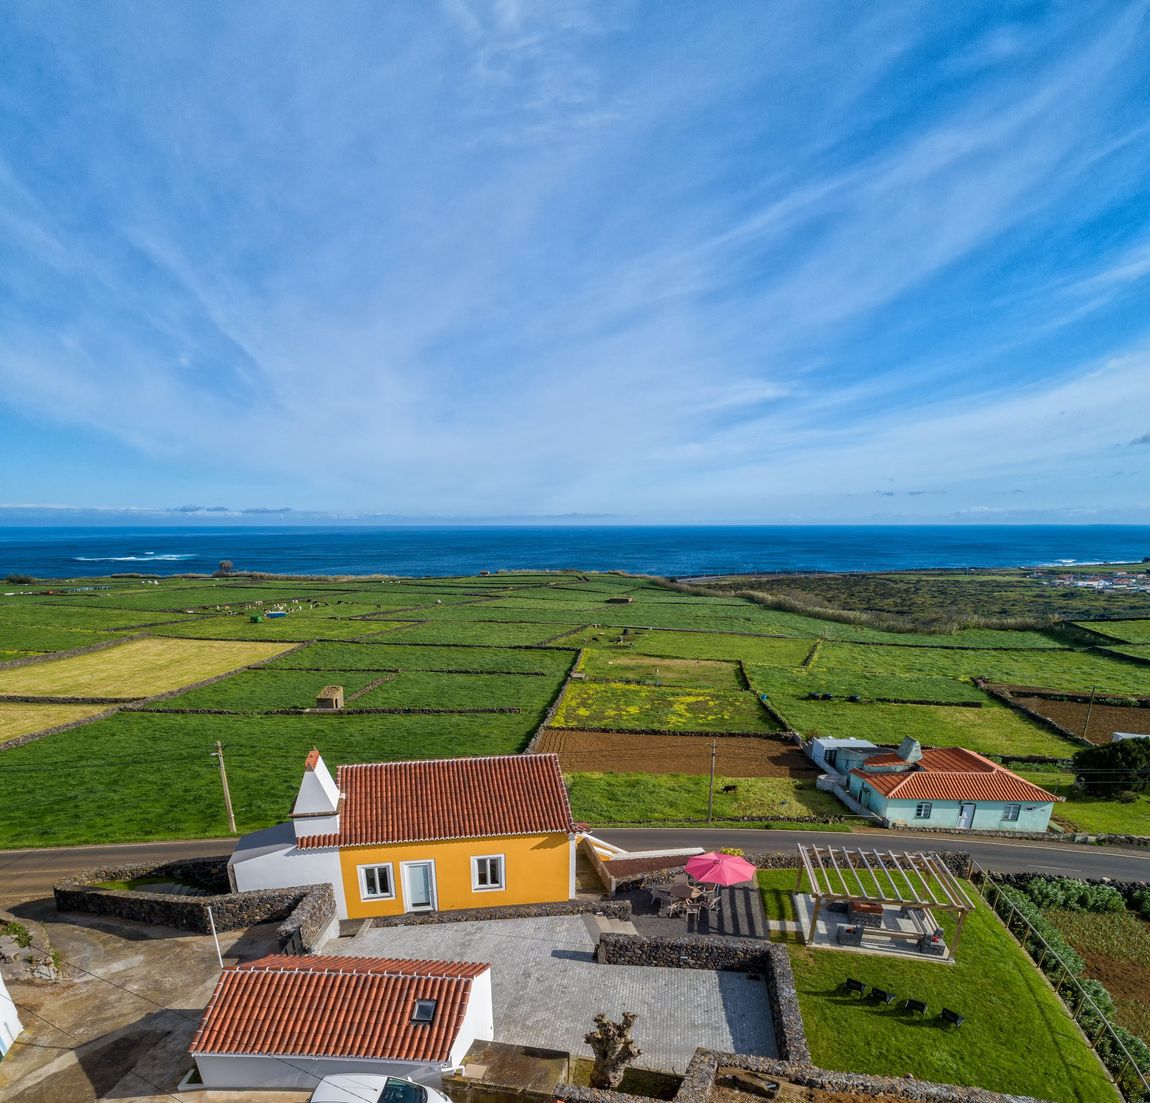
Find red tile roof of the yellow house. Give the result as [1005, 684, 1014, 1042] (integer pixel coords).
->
[297, 755, 574, 850]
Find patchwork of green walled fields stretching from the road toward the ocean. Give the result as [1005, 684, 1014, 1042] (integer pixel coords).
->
[0, 573, 1150, 845]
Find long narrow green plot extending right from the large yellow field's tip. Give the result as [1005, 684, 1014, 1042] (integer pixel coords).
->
[273, 637, 575, 674]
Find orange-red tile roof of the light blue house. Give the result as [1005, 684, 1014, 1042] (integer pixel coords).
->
[851, 746, 1061, 804]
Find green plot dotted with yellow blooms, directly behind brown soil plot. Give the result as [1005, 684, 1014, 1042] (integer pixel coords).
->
[552, 682, 779, 731]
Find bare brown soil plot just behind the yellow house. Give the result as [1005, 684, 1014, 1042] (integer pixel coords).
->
[535, 728, 819, 778]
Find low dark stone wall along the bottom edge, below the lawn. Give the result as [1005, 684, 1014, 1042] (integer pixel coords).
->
[555, 1049, 1036, 1103]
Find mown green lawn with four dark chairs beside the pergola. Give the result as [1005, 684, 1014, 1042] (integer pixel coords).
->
[759, 870, 1117, 1103]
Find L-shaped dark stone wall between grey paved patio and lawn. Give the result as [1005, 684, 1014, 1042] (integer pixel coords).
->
[595, 932, 811, 1064]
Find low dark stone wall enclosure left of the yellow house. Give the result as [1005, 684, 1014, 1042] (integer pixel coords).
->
[53, 856, 338, 953]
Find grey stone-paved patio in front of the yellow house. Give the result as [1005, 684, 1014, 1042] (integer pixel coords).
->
[324, 916, 776, 1072]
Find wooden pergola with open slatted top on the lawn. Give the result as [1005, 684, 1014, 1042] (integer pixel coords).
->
[795, 843, 974, 957]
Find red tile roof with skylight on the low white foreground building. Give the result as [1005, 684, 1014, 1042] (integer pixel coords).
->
[191, 955, 490, 1060]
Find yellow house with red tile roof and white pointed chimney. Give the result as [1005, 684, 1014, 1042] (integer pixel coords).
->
[230, 750, 576, 919]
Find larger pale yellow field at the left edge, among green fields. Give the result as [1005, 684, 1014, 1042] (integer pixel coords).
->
[0, 638, 286, 697]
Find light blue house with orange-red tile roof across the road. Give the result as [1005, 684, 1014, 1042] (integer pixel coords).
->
[848, 740, 1061, 832]
